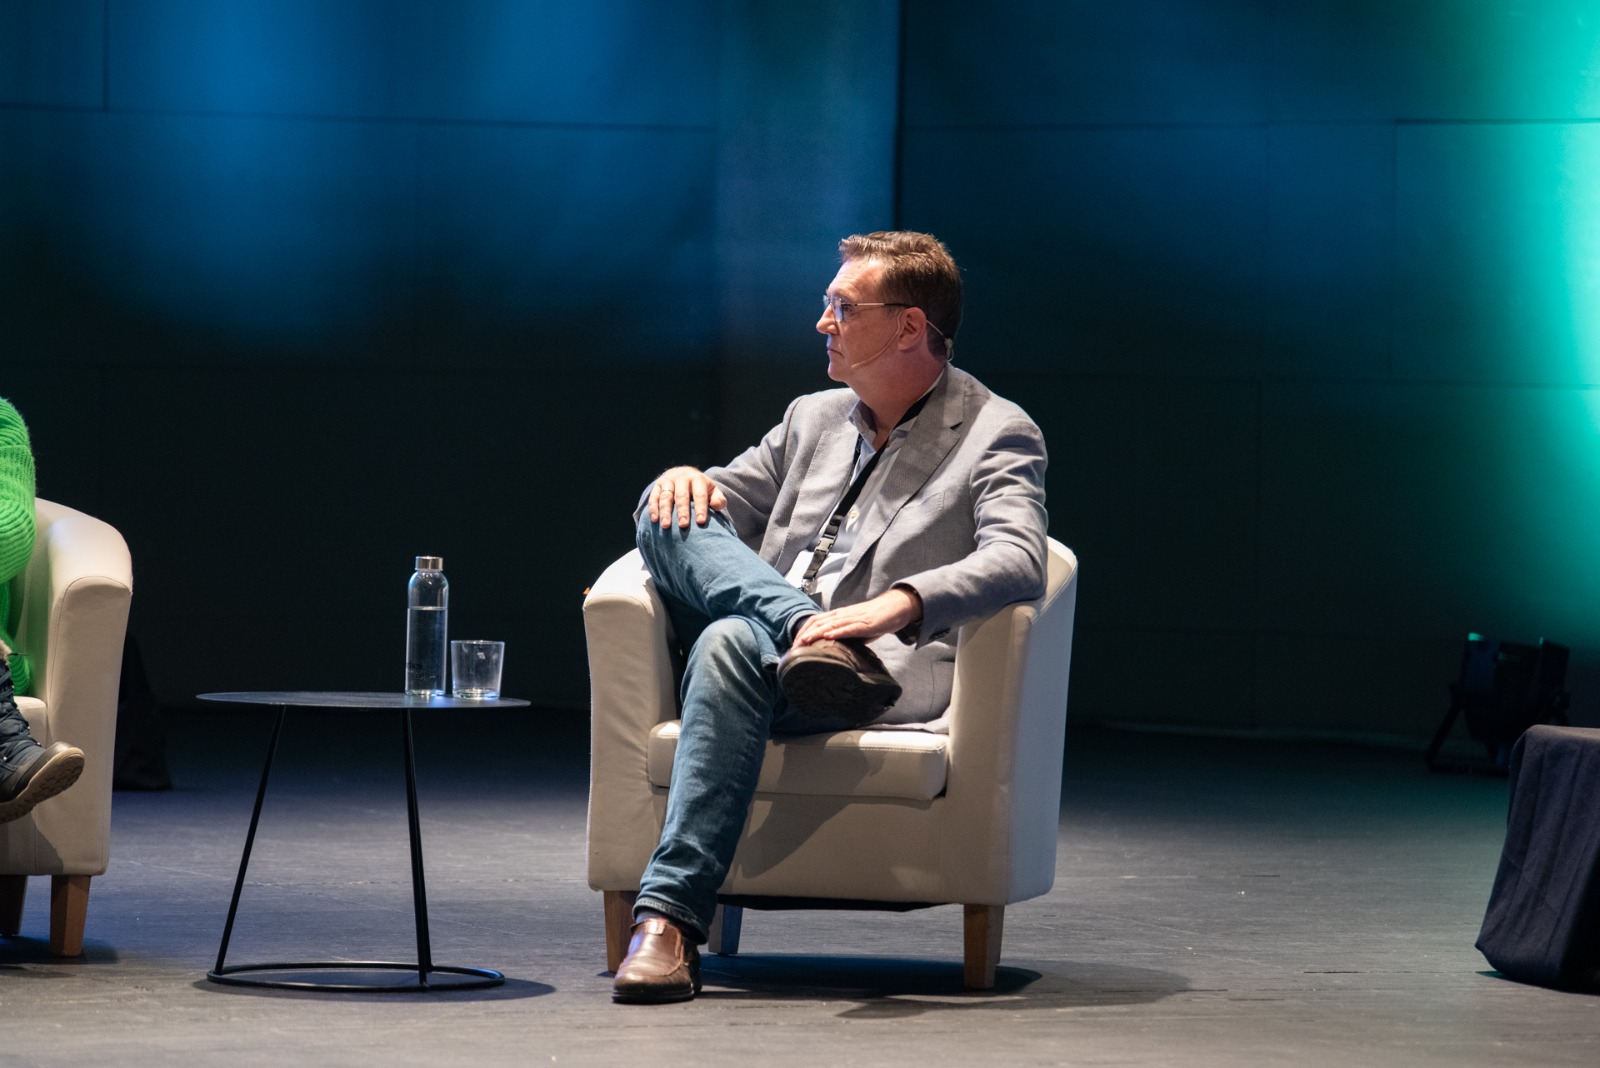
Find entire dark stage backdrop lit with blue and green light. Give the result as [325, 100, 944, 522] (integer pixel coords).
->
[0, 0, 1600, 735]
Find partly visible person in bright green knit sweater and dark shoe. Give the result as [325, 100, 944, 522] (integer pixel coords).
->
[0, 398, 83, 823]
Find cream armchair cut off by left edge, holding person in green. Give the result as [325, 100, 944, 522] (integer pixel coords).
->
[0, 500, 133, 956]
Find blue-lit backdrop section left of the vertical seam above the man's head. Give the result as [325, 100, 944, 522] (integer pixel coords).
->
[0, 0, 898, 708]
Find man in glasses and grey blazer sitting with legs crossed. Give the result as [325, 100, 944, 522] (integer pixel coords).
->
[613, 232, 1046, 1001]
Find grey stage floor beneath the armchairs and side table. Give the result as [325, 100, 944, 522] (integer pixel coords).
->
[0, 710, 1600, 1068]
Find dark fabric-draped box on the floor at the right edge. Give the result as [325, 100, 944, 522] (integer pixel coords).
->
[1477, 726, 1600, 991]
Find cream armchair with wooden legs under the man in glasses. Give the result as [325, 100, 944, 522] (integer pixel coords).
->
[584, 539, 1077, 990]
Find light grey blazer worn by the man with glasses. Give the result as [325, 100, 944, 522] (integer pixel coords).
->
[706, 366, 1048, 723]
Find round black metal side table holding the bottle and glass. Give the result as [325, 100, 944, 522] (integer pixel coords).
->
[200, 691, 528, 993]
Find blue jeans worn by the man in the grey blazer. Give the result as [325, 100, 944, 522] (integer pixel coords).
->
[634, 512, 870, 942]
